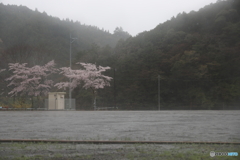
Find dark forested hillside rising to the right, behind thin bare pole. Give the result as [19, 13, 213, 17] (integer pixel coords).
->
[74, 0, 240, 109]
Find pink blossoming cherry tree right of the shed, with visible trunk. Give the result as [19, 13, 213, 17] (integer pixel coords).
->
[55, 62, 112, 109]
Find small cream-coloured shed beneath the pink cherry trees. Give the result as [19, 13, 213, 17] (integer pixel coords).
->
[48, 92, 66, 110]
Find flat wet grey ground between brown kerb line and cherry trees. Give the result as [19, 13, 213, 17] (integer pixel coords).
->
[0, 111, 240, 142]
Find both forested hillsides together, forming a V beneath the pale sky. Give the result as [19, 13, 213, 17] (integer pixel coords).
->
[0, 0, 240, 110]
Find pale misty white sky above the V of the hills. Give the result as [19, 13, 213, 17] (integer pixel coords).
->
[0, 0, 217, 36]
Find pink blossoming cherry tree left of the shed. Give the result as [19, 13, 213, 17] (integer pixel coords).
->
[6, 60, 58, 108]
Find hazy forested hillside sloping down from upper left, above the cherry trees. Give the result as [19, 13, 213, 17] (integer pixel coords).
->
[0, 3, 130, 66]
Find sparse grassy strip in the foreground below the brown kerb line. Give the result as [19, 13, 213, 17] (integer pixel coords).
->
[0, 143, 240, 160]
